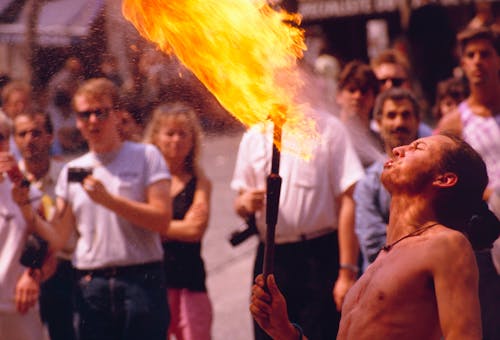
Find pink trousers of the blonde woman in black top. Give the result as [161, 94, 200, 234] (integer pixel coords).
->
[167, 288, 212, 340]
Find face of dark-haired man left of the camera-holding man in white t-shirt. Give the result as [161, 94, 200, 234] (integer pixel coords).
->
[14, 115, 52, 162]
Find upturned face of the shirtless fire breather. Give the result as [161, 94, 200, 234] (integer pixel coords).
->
[381, 135, 453, 194]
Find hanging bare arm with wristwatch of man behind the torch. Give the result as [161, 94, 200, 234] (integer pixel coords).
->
[333, 184, 359, 310]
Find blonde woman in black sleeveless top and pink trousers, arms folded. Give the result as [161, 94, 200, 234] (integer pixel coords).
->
[146, 102, 212, 340]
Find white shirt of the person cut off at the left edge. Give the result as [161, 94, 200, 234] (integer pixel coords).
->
[0, 177, 41, 314]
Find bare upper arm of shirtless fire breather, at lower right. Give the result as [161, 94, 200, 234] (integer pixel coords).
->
[429, 232, 482, 340]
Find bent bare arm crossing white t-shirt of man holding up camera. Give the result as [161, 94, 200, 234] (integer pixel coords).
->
[83, 176, 172, 234]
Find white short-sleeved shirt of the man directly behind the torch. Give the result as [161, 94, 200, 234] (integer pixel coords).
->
[231, 112, 364, 244]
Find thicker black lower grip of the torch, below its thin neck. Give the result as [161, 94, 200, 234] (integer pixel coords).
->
[263, 173, 281, 280]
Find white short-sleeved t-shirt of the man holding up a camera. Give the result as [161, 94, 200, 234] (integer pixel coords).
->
[56, 142, 171, 269]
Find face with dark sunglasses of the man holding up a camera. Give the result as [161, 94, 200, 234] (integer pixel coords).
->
[74, 94, 118, 145]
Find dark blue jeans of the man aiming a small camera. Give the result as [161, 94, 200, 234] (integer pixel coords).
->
[77, 262, 170, 340]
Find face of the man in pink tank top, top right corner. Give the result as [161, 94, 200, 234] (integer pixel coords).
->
[461, 39, 500, 85]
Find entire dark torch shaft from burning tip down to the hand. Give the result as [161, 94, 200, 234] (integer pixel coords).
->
[263, 124, 281, 280]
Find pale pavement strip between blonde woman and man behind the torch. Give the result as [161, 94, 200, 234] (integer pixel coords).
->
[202, 132, 257, 340]
